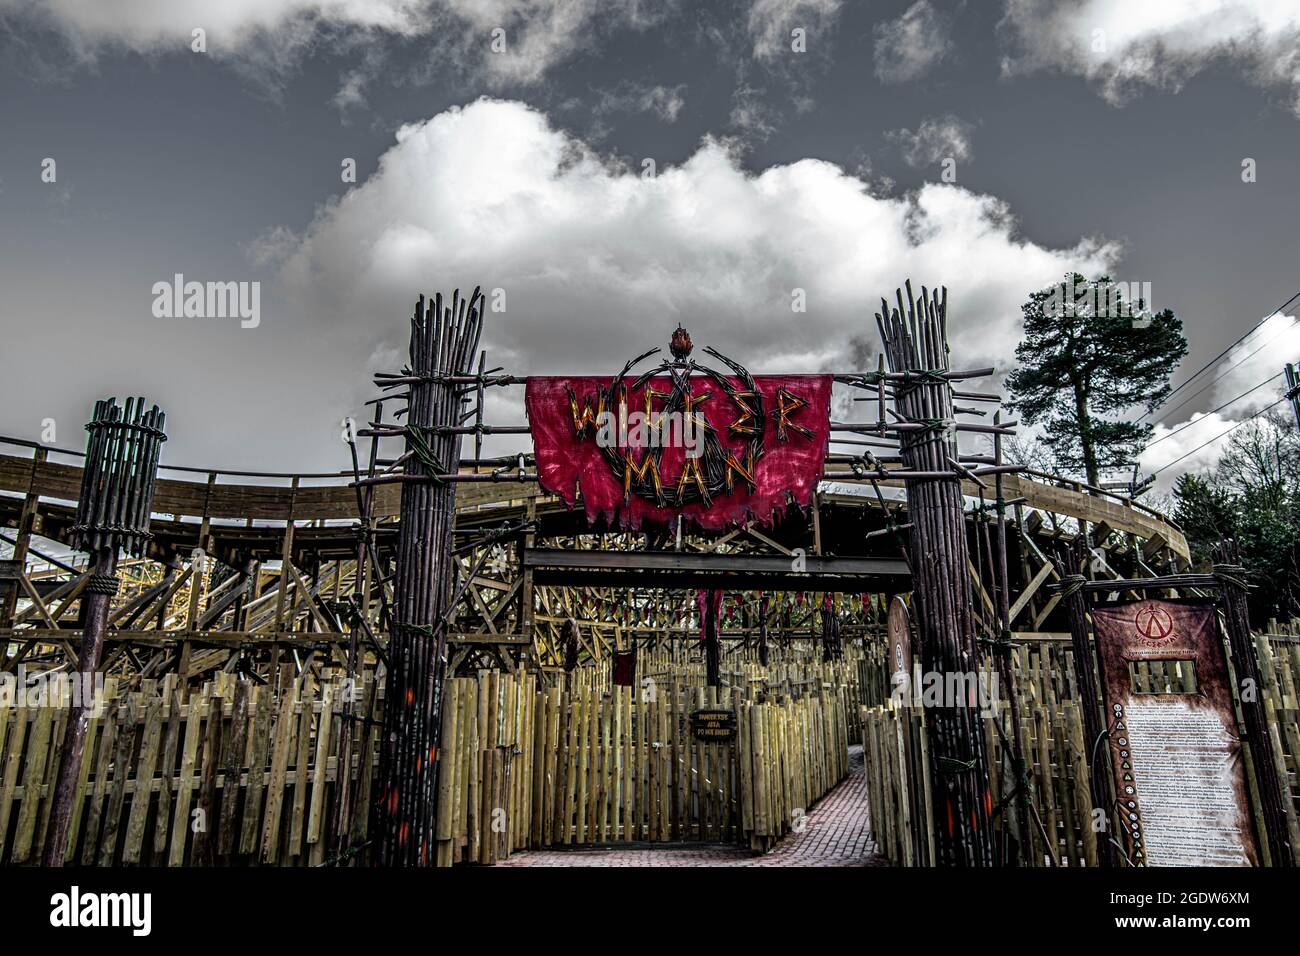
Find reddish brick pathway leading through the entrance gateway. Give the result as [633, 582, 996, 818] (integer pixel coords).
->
[498, 747, 887, 866]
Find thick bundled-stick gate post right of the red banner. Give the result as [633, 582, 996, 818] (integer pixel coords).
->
[876, 282, 993, 866]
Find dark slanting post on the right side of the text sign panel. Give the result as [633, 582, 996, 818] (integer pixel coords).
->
[1214, 554, 1295, 866]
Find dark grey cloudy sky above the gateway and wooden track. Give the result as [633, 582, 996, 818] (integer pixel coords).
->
[0, 0, 1300, 481]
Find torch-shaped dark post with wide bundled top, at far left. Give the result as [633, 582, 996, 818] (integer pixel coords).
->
[42, 398, 166, 866]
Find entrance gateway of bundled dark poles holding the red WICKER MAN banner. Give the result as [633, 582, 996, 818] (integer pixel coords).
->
[359, 284, 1018, 865]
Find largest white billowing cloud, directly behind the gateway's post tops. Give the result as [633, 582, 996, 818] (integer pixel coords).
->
[273, 100, 1117, 416]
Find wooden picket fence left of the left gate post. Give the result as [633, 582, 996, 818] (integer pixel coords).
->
[0, 674, 377, 866]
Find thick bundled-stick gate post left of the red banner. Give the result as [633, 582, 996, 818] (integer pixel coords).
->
[373, 289, 484, 866]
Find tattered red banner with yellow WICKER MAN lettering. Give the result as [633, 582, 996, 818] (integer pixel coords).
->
[525, 375, 831, 531]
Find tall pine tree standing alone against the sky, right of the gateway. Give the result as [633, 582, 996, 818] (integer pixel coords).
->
[1006, 273, 1187, 485]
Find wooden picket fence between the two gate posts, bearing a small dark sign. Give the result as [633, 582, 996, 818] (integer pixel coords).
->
[437, 671, 853, 865]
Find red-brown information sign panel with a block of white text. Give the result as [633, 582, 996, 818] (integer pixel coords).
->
[1092, 601, 1260, 866]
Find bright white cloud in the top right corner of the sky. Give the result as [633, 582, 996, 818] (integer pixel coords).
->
[1002, 0, 1300, 116]
